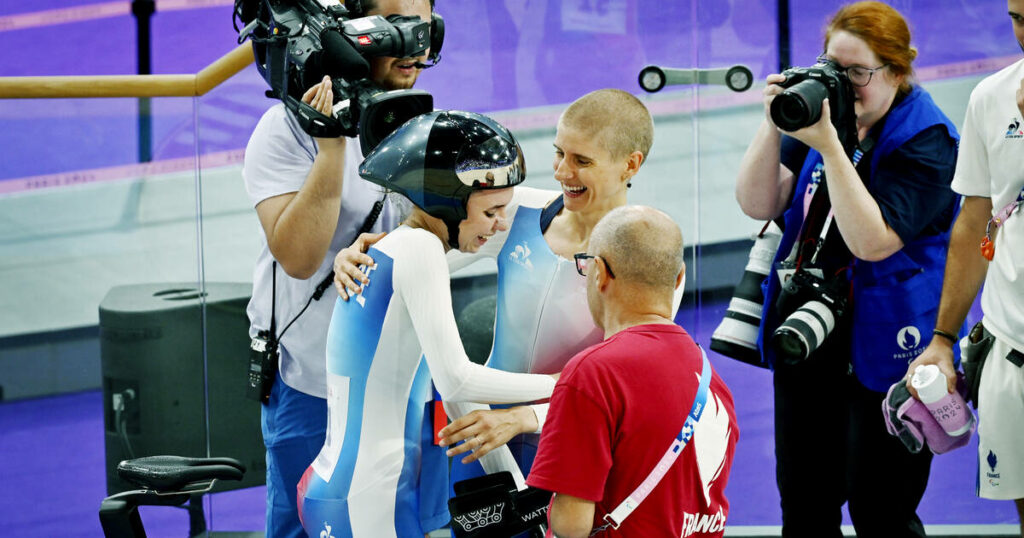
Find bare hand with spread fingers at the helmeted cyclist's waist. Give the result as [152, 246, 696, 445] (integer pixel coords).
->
[438, 406, 538, 463]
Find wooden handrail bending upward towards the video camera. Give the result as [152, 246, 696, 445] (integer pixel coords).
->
[0, 43, 253, 99]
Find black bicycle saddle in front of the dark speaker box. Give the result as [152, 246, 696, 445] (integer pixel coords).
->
[118, 456, 246, 492]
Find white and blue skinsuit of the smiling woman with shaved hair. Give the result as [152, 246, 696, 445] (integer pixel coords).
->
[442, 187, 683, 487]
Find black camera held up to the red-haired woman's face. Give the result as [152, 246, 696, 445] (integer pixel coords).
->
[770, 57, 857, 148]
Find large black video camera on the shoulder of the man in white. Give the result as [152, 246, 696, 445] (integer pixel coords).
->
[233, 0, 444, 154]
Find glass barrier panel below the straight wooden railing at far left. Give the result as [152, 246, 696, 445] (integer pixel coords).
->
[0, 92, 206, 536]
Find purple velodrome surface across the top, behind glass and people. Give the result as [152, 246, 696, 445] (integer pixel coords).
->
[0, 0, 1018, 180]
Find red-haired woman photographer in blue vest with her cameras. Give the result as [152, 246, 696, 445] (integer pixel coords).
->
[736, 2, 957, 537]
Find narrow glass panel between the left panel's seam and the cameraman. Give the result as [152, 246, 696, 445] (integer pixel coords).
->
[197, 61, 268, 532]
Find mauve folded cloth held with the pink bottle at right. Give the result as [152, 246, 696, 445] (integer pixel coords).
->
[882, 372, 977, 454]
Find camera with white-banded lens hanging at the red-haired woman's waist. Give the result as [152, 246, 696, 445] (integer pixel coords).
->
[771, 268, 848, 365]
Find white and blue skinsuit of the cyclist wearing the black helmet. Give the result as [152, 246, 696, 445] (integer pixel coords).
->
[299, 226, 554, 538]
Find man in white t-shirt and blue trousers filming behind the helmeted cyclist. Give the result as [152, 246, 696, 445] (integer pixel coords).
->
[243, 0, 438, 537]
